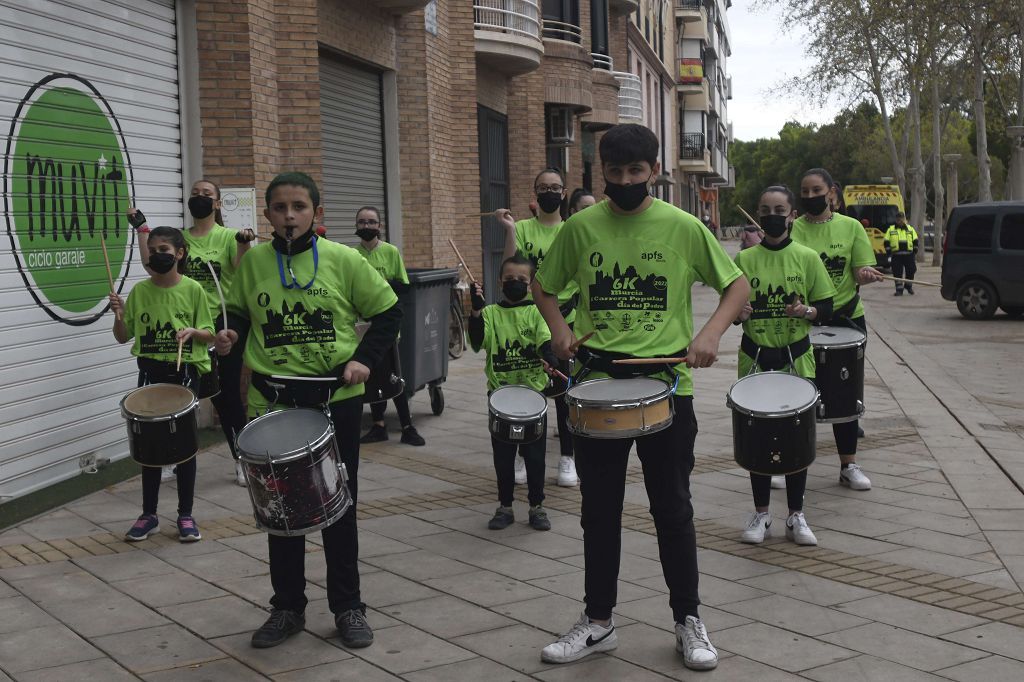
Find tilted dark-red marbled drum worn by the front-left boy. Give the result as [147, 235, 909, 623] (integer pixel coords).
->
[236, 408, 352, 536]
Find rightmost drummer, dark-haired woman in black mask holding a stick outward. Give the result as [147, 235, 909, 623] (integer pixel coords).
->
[790, 168, 882, 491]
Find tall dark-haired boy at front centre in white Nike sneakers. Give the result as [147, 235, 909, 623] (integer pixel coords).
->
[534, 124, 750, 670]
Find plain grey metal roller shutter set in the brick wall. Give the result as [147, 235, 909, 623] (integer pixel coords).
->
[319, 57, 387, 245]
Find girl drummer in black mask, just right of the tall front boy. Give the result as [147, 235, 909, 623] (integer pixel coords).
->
[736, 185, 836, 545]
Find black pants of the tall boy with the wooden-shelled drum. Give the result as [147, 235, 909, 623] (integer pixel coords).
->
[572, 396, 700, 623]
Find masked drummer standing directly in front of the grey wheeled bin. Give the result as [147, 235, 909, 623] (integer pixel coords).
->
[355, 206, 427, 445]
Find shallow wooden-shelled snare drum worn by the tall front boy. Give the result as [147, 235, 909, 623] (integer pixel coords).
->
[565, 377, 676, 438]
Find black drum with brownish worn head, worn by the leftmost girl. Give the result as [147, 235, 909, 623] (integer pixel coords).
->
[121, 384, 199, 467]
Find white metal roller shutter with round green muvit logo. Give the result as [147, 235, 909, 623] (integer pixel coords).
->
[0, 0, 182, 501]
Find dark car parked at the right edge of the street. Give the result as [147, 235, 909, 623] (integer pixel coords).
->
[942, 202, 1024, 319]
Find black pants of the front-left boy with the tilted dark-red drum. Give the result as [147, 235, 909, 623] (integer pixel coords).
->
[267, 395, 366, 614]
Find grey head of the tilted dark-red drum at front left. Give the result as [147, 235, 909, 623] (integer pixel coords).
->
[236, 408, 331, 462]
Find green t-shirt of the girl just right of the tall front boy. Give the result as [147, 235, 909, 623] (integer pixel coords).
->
[736, 241, 836, 379]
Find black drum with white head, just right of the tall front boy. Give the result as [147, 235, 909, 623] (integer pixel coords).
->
[725, 372, 818, 476]
